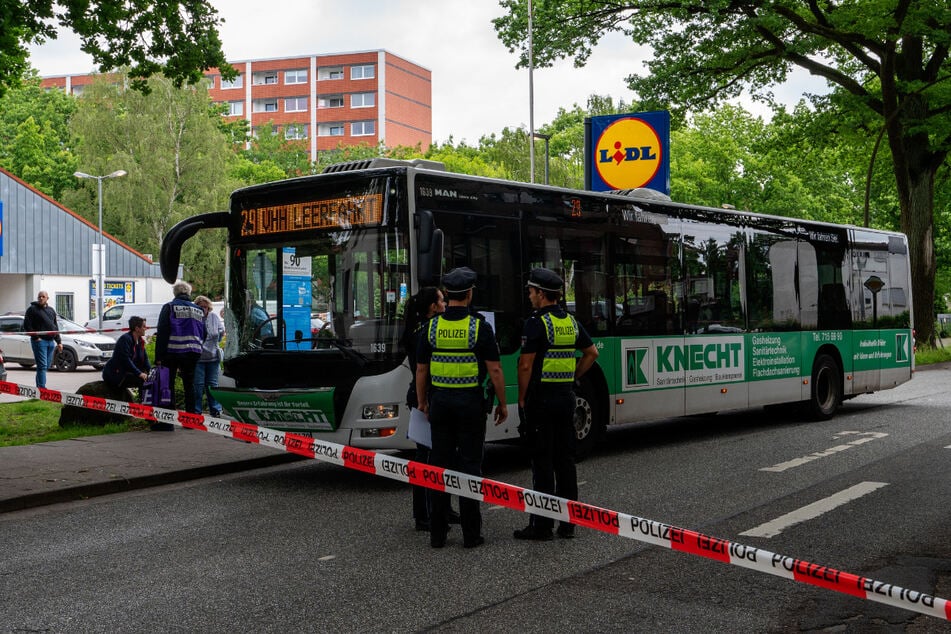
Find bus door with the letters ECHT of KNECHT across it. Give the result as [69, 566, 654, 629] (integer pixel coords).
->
[676, 212, 749, 414]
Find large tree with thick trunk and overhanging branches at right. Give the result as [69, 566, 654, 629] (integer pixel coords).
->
[495, 0, 951, 343]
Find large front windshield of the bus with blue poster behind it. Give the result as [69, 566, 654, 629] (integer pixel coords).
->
[225, 175, 410, 371]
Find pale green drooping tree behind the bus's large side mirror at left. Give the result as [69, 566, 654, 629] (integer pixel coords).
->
[64, 72, 239, 297]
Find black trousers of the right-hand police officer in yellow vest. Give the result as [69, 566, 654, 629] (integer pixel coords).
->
[525, 385, 578, 530]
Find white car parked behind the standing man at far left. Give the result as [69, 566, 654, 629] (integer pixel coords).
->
[0, 313, 116, 372]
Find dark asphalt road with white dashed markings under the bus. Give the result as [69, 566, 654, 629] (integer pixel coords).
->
[0, 369, 951, 632]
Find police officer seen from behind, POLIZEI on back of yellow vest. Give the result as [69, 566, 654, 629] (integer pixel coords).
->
[416, 267, 508, 548]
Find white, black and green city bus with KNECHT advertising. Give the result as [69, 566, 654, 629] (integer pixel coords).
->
[161, 159, 914, 456]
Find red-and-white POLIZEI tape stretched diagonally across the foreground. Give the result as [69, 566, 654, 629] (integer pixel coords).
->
[0, 381, 951, 621]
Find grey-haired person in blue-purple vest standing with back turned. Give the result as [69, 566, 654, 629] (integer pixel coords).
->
[152, 280, 205, 424]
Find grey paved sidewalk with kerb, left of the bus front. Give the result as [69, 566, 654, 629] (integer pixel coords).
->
[0, 427, 304, 513]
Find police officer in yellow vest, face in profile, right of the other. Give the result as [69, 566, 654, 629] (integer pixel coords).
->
[514, 268, 598, 541]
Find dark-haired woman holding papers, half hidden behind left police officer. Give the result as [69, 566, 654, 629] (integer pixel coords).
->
[400, 286, 459, 532]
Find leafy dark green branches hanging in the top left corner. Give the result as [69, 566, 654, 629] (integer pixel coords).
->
[0, 0, 237, 95]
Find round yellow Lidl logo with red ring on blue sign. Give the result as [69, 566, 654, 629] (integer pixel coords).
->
[594, 117, 661, 189]
